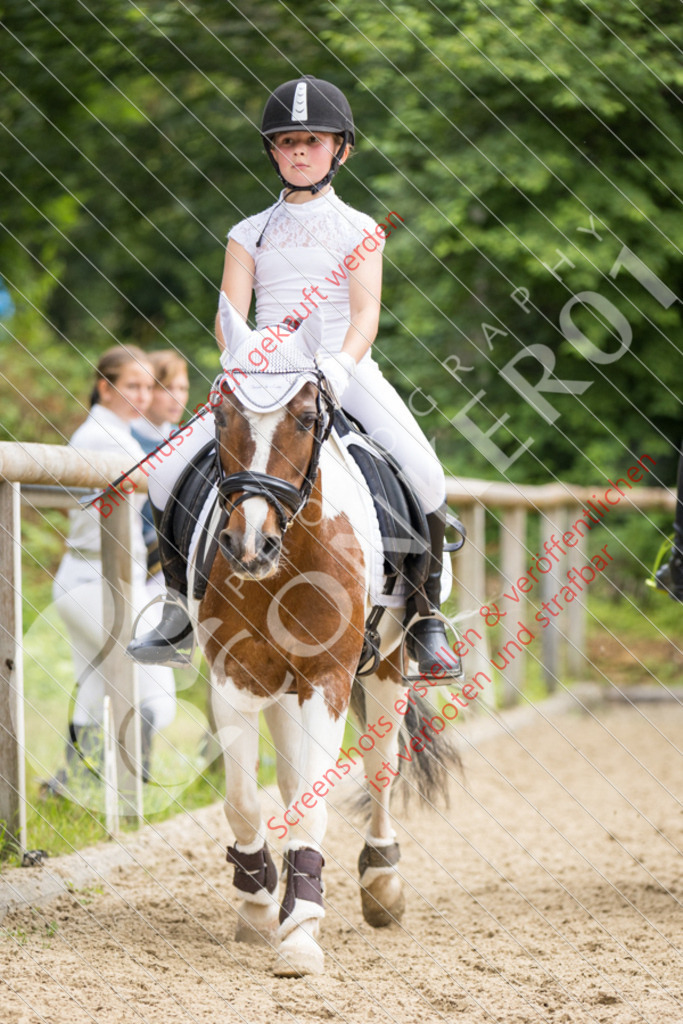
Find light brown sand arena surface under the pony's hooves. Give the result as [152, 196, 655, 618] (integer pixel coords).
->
[0, 703, 683, 1024]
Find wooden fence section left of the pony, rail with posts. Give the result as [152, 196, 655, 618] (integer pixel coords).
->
[0, 442, 146, 850]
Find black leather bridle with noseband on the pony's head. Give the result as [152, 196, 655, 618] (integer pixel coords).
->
[214, 370, 335, 534]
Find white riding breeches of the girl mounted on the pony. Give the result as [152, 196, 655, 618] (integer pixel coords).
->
[148, 359, 445, 513]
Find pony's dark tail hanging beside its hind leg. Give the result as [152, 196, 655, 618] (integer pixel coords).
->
[350, 679, 463, 817]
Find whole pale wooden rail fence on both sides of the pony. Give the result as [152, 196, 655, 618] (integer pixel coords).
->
[0, 442, 675, 850]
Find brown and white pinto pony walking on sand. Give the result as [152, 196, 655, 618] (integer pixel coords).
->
[190, 297, 456, 976]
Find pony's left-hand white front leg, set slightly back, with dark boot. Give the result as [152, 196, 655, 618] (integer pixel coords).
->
[212, 682, 278, 945]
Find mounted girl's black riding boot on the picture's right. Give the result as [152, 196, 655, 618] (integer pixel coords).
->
[405, 502, 462, 679]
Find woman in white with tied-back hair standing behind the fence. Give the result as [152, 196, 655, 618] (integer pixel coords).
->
[48, 345, 176, 791]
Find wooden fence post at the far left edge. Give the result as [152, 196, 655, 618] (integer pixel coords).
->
[0, 480, 26, 851]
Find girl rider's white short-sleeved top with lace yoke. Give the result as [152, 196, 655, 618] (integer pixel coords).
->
[228, 188, 384, 358]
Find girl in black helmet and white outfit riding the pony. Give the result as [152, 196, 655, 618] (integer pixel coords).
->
[129, 77, 458, 673]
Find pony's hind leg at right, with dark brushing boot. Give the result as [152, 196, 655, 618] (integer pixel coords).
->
[358, 662, 405, 928]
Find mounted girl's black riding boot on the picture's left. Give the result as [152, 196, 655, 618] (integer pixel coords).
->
[126, 503, 195, 668]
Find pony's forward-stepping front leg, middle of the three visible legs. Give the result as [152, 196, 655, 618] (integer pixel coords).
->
[275, 678, 351, 977]
